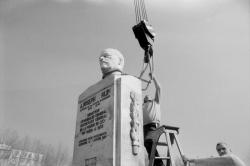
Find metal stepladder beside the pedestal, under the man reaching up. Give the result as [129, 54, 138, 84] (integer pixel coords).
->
[145, 125, 186, 166]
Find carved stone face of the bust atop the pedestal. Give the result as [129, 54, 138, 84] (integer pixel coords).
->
[99, 49, 120, 74]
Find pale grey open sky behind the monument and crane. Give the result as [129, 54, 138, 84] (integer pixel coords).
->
[0, 0, 250, 164]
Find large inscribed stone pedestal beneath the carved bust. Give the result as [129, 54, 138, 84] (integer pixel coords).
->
[73, 75, 145, 166]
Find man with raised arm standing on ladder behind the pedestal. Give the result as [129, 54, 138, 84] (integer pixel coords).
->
[143, 73, 164, 166]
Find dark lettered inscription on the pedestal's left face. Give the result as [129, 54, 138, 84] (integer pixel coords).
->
[78, 87, 111, 146]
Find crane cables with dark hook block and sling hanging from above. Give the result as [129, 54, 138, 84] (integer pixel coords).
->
[132, 0, 155, 90]
